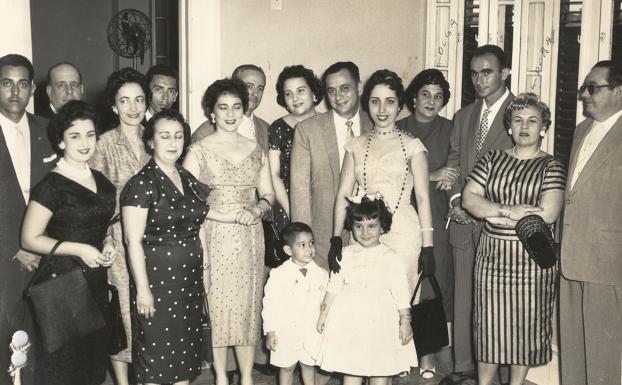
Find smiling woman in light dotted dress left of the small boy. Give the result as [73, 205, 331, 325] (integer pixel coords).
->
[183, 79, 274, 385]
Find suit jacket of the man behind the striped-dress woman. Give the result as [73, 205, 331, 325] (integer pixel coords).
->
[447, 92, 514, 243]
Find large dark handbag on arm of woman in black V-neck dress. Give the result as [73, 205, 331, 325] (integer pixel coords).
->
[25, 241, 106, 353]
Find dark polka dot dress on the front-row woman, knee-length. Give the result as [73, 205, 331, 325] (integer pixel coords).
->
[121, 160, 208, 384]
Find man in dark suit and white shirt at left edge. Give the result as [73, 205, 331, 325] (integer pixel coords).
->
[0, 54, 56, 385]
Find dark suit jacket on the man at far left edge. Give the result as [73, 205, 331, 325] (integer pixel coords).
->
[0, 114, 56, 312]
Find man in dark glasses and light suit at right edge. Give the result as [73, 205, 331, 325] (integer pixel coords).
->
[559, 61, 622, 385]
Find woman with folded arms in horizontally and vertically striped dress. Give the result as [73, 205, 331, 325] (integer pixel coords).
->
[463, 93, 566, 385]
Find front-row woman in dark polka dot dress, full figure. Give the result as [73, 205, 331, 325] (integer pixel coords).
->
[121, 110, 235, 384]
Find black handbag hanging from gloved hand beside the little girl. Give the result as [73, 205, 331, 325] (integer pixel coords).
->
[410, 275, 449, 357]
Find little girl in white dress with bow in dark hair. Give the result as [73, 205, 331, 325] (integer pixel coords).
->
[317, 193, 417, 385]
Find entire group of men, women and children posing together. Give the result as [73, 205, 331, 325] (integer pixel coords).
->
[0, 41, 622, 385]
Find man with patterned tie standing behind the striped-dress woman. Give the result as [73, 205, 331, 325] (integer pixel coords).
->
[441, 45, 514, 385]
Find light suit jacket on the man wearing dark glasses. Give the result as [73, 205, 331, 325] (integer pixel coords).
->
[561, 114, 622, 286]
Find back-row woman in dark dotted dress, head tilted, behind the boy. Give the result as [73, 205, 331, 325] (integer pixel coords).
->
[268, 65, 323, 230]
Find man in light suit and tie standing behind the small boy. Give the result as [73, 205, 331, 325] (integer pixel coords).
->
[289, 62, 373, 269]
